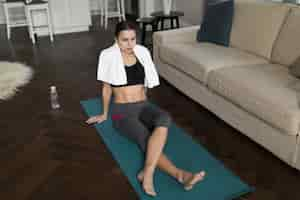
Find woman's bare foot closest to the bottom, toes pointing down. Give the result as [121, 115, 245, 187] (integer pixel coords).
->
[137, 167, 156, 196]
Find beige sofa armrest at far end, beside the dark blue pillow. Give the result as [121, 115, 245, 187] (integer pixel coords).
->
[153, 26, 200, 45]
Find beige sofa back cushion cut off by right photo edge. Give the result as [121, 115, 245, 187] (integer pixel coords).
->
[272, 7, 300, 65]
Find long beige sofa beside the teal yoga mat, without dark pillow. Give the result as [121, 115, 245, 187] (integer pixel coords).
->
[153, 0, 300, 169]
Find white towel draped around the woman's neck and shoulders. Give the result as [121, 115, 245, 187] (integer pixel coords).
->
[97, 43, 159, 88]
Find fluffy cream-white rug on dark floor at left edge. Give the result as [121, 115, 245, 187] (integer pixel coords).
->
[0, 62, 33, 100]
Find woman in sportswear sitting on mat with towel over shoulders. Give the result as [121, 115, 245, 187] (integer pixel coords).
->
[86, 21, 205, 196]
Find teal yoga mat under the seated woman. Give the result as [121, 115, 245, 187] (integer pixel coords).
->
[80, 98, 253, 200]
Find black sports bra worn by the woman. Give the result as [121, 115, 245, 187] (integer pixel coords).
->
[111, 59, 145, 87]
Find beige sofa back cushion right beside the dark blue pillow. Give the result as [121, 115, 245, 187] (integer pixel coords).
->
[230, 0, 289, 59]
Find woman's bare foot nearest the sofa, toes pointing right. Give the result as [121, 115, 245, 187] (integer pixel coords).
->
[177, 171, 205, 190]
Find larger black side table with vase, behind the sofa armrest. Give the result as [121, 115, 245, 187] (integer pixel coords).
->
[151, 11, 184, 30]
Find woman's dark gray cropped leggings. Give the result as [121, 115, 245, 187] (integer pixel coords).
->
[111, 100, 171, 152]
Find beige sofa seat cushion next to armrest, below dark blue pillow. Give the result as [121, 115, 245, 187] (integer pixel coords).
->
[159, 42, 268, 84]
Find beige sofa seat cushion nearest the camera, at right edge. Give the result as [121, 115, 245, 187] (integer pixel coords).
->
[208, 64, 300, 135]
